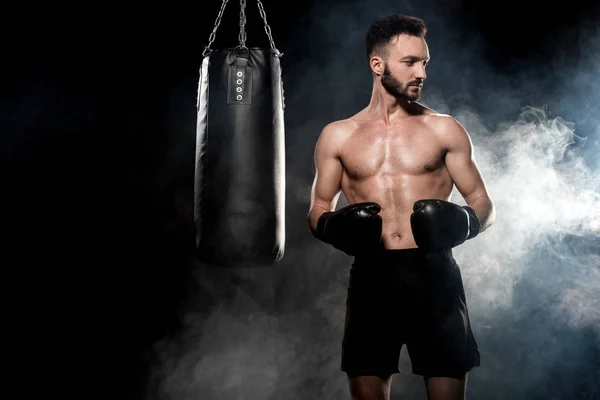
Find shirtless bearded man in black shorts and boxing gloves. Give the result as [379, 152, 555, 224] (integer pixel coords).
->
[308, 15, 495, 400]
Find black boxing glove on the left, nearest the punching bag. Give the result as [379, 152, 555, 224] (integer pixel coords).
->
[313, 202, 382, 256]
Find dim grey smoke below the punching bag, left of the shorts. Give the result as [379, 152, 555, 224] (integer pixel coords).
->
[147, 244, 348, 400]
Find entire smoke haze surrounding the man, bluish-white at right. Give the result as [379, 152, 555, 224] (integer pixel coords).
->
[147, 1, 600, 400]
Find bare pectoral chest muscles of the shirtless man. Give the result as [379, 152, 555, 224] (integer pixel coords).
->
[341, 124, 445, 179]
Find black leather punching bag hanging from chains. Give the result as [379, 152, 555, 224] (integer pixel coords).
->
[194, 47, 285, 267]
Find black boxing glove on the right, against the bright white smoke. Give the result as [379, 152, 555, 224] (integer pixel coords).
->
[410, 199, 481, 251]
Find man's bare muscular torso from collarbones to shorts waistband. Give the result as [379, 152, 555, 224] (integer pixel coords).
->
[339, 109, 453, 249]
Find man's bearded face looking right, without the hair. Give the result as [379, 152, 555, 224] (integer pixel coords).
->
[381, 34, 429, 101]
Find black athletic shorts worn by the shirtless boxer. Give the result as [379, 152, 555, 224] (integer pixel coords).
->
[341, 249, 480, 378]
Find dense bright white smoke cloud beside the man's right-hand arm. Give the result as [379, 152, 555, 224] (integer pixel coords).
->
[454, 107, 600, 334]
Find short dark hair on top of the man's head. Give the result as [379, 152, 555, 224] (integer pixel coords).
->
[366, 14, 427, 58]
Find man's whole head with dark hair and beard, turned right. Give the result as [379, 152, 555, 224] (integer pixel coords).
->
[366, 14, 429, 101]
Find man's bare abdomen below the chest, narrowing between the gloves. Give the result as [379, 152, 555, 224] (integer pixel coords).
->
[342, 169, 453, 249]
